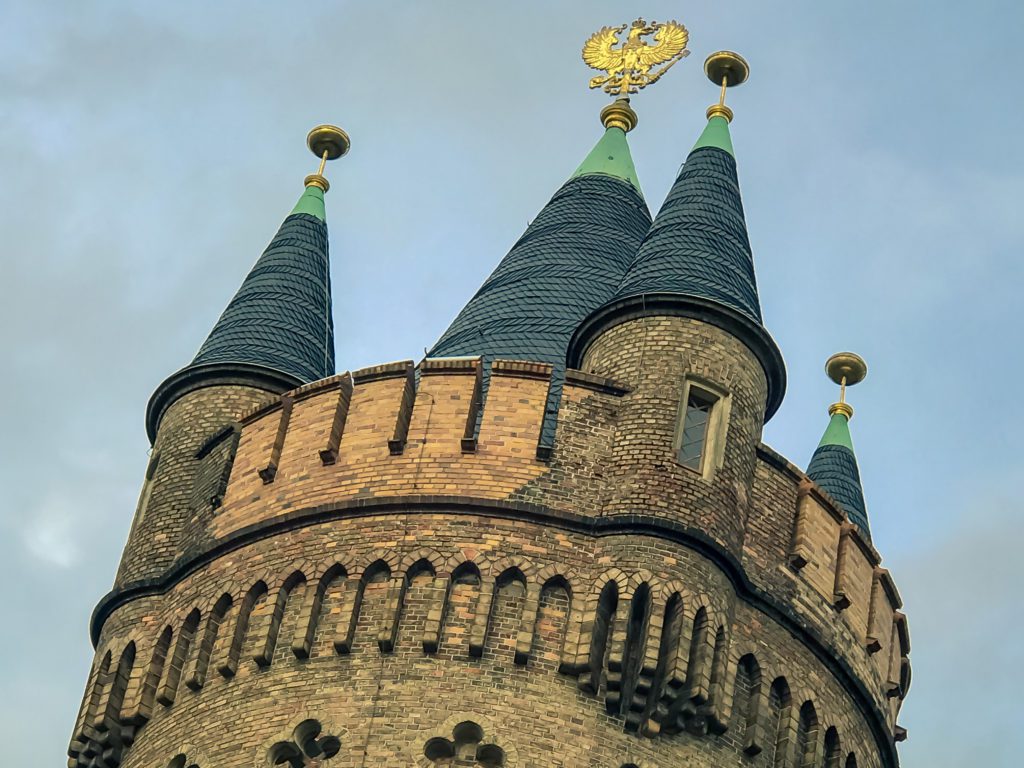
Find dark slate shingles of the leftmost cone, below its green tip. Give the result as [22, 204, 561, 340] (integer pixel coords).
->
[189, 213, 334, 383]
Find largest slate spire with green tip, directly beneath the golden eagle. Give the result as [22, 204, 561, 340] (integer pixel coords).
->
[429, 99, 650, 368]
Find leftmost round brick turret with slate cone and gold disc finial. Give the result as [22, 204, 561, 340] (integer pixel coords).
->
[117, 126, 349, 585]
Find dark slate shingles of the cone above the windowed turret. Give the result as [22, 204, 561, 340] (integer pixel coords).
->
[615, 146, 761, 325]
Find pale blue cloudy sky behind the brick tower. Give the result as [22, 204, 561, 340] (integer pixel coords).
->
[0, 0, 1024, 768]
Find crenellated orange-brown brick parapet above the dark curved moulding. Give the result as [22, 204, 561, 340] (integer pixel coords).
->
[94, 357, 909, 749]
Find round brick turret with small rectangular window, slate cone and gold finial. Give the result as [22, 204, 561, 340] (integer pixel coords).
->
[568, 52, 785, 553]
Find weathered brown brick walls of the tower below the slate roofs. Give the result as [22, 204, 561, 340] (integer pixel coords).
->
[77, 339, 909, 768]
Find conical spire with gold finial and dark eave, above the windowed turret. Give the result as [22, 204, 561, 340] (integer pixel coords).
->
[569, 53, 785, 418]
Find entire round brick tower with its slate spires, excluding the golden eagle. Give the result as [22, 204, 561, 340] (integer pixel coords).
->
[69, 40, 910, 768]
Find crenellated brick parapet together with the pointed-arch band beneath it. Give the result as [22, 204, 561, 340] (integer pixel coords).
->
[81, 358, 909, 766]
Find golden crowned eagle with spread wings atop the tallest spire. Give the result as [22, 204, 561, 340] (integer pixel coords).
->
[583, 18, 690, 96]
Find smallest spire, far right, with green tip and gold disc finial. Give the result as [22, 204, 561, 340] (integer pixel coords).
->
[807, 352, 871, 540]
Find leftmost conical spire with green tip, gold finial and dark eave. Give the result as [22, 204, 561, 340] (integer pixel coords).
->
[146, 126, 348, 439]
